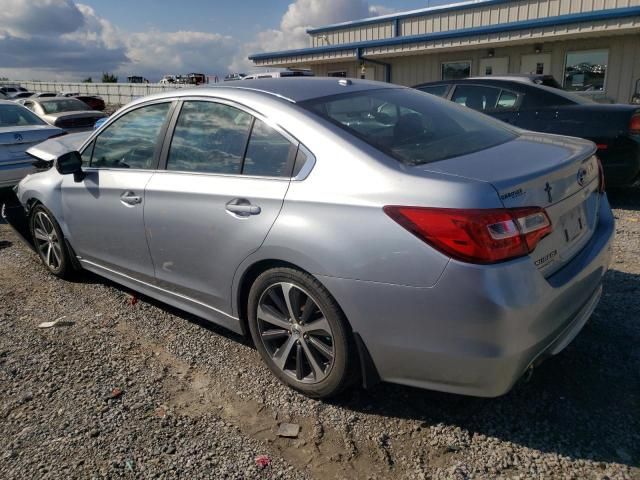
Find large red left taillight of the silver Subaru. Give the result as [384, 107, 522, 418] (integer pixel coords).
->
[384, 205, 552, 264]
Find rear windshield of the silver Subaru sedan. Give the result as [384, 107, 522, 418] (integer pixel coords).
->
[301, 88, 517, 165]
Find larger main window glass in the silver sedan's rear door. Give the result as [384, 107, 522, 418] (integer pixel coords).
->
[167, 101, 253, 174]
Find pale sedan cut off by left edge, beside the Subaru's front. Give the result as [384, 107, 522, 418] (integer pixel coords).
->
[0, 100, 65, 188]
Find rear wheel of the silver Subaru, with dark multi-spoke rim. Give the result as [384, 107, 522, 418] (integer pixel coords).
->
[247, 268, 357, 398]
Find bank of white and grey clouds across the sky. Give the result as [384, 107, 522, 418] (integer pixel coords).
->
[0, 0, 398, 81]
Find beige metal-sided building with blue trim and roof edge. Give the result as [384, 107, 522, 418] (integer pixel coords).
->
[249, 0, 640, 102]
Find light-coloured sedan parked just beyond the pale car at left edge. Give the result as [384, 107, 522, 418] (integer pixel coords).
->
[19, 97, 106, 133]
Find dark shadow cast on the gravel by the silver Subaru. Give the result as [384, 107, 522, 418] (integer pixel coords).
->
[67, 264, 640, 467]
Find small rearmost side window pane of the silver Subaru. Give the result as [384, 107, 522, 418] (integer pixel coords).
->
[242, 119, 293, 177]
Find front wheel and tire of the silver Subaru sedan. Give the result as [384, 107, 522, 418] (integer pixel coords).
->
[29, 205, 73, 278]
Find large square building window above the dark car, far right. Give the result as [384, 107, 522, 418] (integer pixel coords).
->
[563, 50, 609, 93]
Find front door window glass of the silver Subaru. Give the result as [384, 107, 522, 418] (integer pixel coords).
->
[91, 103, 171, 169]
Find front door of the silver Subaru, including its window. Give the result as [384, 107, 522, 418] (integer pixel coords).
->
[62, 100, 173, 282]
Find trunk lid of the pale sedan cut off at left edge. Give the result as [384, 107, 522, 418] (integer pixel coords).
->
[0, 125, 64, 165]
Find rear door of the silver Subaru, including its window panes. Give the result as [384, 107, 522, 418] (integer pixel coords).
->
[145, 99, 297, 313]
